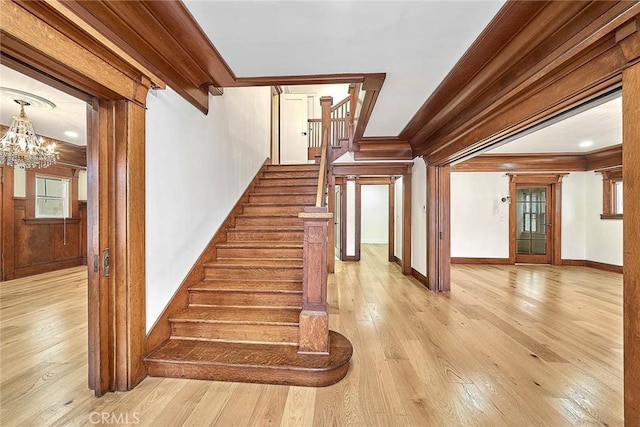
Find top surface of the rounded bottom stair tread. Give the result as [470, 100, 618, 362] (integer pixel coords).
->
[145, 331, 353, 371]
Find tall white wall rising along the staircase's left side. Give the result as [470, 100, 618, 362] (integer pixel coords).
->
[145, 87, 271, 331]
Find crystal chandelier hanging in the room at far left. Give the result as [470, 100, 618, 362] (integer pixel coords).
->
[0, 99, 60, 168]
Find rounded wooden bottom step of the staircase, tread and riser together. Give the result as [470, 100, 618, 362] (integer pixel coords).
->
[145, 331, 353, 387]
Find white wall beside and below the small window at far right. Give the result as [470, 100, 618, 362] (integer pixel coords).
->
[584, 172, 622, 265]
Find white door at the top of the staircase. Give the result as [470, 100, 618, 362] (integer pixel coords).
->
[280, 94, 309, 165]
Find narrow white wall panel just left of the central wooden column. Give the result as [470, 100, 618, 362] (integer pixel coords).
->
[411, 157, 427, 276]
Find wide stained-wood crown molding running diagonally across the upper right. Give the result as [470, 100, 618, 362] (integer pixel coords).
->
[399, 1, 640, 164]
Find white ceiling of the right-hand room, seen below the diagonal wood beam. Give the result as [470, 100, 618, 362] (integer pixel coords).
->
[487, 96, 622, 154]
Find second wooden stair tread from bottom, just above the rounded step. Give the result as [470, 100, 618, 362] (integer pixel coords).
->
[169, 306, 300, 325]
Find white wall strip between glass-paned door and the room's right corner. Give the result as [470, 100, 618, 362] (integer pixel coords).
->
[560, 172, 588, 260]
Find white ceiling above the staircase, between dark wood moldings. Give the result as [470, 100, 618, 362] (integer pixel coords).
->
[185, 0, 504, 136]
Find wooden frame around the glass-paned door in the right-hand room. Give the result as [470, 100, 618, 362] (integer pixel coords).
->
[508, 173, 567, 265]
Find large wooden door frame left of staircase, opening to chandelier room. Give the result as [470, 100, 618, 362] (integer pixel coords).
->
[0, 2, 157, 396]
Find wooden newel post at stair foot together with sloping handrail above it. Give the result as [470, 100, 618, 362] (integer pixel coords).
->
[298, 96, 333, 354]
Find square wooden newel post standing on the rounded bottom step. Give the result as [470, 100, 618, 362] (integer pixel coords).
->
[298, 207, 333, 354]
